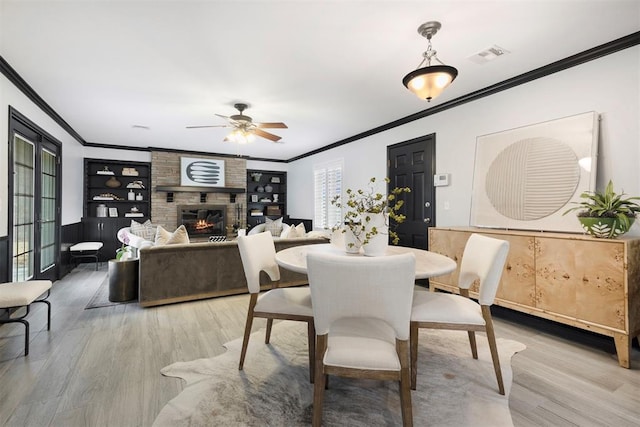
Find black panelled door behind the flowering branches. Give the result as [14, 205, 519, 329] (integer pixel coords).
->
[387, 134, 436, 249]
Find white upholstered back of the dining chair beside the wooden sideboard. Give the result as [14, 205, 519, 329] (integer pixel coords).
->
[458, 234, 509, 305]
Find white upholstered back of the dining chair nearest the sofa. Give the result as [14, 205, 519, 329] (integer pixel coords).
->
[238, 231, 280, 294]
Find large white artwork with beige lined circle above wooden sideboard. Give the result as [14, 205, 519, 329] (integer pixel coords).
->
[471, 111, 598, 232]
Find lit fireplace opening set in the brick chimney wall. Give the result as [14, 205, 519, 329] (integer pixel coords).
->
[178, 205, 227, 236]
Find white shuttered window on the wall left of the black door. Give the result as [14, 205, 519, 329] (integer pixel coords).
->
[313, 160, 343, 229]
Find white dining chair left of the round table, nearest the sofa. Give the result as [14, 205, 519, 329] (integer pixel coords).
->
[238, 231, 316, 382]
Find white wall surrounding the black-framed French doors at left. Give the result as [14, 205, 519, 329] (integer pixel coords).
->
[0, 74, 84, 236]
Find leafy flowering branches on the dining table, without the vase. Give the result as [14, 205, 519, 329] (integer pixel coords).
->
[331, 177, 411, 246]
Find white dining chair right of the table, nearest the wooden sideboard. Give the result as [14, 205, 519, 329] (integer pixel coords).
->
[411, 234, 509, 395]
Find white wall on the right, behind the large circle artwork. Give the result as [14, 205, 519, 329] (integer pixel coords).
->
[287, 46, 640, 234]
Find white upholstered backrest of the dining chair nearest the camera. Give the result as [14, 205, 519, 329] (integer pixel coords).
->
[307, 253, 415, 340]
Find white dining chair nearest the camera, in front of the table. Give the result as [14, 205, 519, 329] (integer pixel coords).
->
[307, 253, 415, 426]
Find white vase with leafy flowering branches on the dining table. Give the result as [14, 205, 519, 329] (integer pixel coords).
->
[331, 177, 411, 256]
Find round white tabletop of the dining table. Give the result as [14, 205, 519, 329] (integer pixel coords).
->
[276, 243, 456, 279]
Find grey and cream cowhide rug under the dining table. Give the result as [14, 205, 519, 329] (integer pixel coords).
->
[153, 322, 526, 427]
